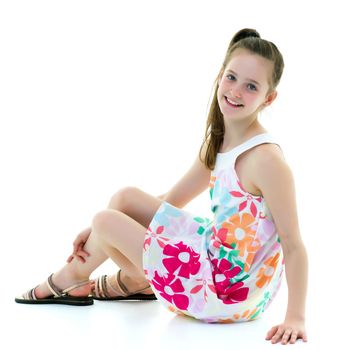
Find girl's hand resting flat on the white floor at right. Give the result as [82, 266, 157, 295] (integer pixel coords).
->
[265, 318, 307, 344]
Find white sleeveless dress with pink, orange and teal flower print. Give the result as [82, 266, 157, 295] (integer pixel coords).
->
[143, 133, 284, 323]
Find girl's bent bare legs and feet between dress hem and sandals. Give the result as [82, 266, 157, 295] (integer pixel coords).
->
[35, 187, 162, 298]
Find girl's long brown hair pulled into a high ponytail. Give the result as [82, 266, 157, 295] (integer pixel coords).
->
[199, 28, 284, 170]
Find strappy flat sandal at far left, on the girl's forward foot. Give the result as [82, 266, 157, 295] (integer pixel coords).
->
[15, 274, 94, 306]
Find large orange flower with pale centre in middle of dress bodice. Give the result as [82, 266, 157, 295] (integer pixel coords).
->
[222, 213, 256, 257]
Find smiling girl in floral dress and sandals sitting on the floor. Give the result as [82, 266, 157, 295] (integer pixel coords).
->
[15, 29, 307, 344]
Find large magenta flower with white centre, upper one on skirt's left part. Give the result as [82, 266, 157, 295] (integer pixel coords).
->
[163, 242, 201, 278]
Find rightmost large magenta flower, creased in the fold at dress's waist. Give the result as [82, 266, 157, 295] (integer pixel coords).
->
[212, 259, 249, 304]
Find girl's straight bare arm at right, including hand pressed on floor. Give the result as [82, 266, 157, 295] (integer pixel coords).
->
[253, 149, 308, 343]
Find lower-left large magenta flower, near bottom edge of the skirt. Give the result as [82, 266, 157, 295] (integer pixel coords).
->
[152, 271, 189, 310]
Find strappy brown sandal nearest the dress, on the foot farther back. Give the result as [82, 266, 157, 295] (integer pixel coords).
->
[92, 270, 157, 300]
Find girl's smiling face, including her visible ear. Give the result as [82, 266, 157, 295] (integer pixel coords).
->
[217, 48, 277, 119]
